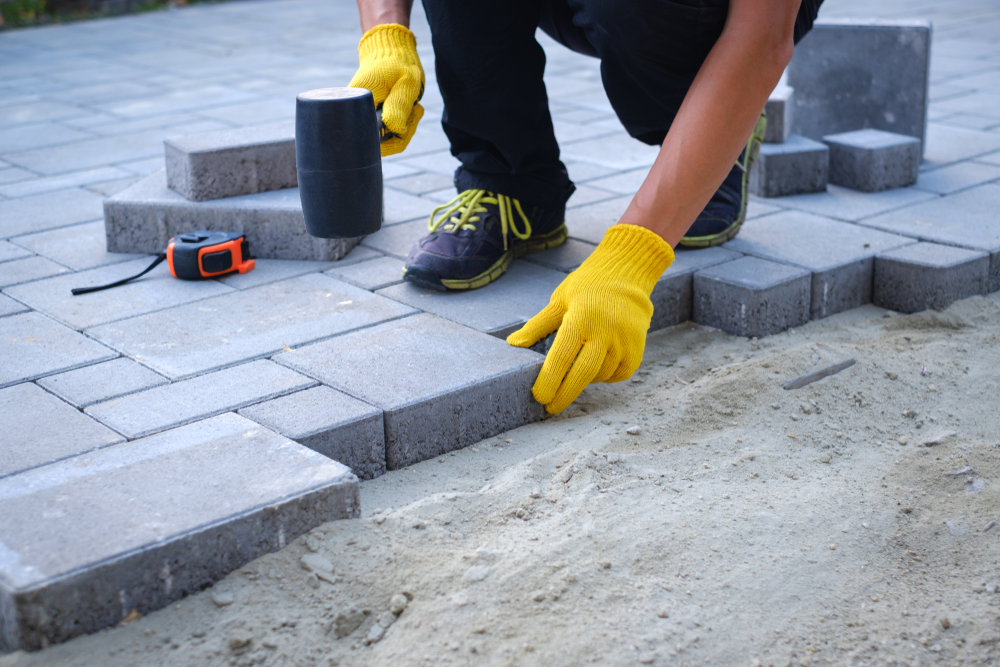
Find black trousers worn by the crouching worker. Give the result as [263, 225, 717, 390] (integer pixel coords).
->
[424, 0, 822, 208]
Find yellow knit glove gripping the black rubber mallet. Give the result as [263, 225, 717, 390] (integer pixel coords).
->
[348, 23, 424, 157]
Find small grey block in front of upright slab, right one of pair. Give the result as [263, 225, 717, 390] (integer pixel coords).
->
[823, 130, 921, 192]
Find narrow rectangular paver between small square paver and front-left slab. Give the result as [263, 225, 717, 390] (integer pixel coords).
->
[90, 359, 316, 440]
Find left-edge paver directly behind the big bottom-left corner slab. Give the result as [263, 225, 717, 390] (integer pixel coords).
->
[0, 382, 124, 480]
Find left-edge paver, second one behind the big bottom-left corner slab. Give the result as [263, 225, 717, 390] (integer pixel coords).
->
[0, 312, 118, 387]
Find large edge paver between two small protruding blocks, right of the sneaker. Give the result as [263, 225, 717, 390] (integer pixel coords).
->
[725, 211, 915, 320]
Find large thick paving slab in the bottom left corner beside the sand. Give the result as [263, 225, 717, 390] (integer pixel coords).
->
[0, 414, 360, 651]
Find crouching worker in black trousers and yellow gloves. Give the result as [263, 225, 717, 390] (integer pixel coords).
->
[350, 0, 822, 413]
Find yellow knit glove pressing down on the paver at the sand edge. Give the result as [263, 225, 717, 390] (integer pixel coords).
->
[507, 225, 674, 414]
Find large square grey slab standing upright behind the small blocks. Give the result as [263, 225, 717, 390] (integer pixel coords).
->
[788, 18, 931, 155]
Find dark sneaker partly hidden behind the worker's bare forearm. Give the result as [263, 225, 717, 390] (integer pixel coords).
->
[681, 113, 767, 248]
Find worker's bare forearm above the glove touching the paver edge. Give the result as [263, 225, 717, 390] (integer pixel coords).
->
[620, 0, 800, 246]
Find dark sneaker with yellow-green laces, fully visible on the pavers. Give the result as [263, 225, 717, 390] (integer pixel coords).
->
[403, 190, 567, 292]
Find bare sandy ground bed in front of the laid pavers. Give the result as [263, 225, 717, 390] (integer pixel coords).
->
[0, 295, 1000, 667]
